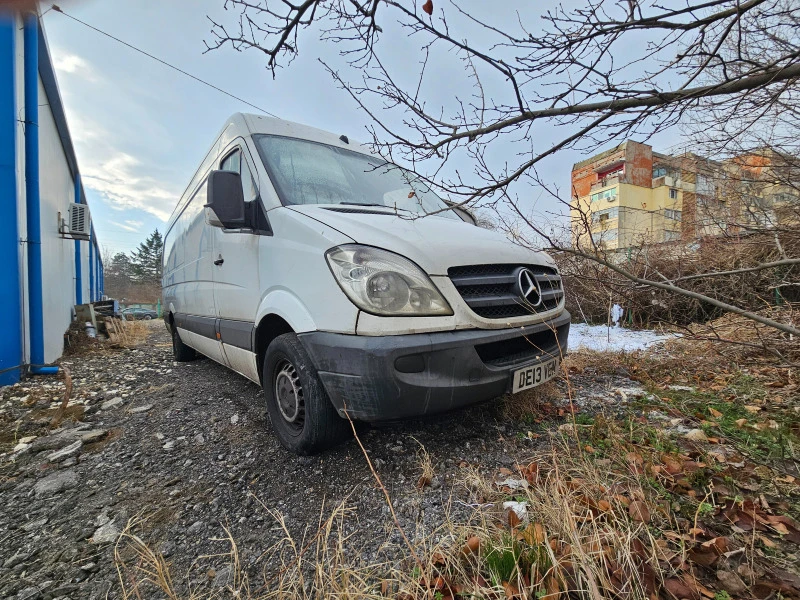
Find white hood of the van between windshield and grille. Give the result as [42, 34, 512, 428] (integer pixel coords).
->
[287, 204, 555, 275]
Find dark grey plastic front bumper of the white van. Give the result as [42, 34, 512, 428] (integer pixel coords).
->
[298, 311, 570, 421]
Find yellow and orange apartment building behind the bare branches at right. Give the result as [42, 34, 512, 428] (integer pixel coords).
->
[571, 140, 800, 250]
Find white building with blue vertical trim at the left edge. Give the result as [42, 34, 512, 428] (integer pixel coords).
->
[0, 7, 103, 385]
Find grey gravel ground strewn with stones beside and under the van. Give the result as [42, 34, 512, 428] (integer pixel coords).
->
[0, 323, 642, 599]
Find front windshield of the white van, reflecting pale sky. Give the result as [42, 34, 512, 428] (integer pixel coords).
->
[255, 135, 461, 220]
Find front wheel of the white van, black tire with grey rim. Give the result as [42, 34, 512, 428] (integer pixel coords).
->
[262, 333, 352, 455]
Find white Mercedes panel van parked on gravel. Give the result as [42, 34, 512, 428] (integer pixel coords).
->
[163, 114, 570, 454]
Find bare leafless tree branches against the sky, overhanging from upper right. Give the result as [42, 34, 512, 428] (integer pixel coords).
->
[207, 0, 800, 335]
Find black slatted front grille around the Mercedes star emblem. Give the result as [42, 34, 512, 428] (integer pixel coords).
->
[447, 264, 564, 319]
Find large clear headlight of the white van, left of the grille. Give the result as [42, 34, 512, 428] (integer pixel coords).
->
[325, 244, 453, 317]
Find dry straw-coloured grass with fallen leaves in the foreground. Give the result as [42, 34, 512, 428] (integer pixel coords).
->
[115, 431, 680, 600]
